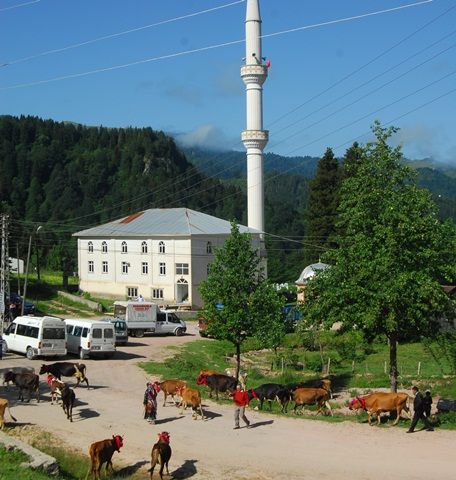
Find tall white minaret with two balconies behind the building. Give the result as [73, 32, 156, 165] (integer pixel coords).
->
[241, 0, 269, 236]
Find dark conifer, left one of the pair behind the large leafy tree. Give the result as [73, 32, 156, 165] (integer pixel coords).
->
[304, 148, 340, 265]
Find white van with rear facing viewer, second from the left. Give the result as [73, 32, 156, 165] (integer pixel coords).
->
[65, 318, 116, 359]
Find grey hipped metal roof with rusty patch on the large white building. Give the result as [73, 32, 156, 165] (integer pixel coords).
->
[73, 208, 261, 238]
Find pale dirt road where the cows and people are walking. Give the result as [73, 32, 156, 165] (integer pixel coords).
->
[0, 325, 456, 480]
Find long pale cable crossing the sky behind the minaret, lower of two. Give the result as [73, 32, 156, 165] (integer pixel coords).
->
[0, 0, 434, 91]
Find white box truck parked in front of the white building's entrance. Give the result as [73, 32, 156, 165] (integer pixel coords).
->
[114, 300, 187, 337]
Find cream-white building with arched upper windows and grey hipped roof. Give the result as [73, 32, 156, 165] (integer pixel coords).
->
[73, 208, 260, 308]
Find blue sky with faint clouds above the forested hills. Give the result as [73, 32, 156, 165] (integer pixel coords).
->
[0, 0, 456, 166]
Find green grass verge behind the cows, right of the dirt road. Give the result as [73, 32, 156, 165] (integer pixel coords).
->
[140, 334, 456, 429]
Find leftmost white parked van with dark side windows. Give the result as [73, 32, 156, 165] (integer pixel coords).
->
[3, 315, 67, 360]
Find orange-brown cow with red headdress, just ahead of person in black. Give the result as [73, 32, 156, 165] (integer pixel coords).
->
[348, 392, 411, 425]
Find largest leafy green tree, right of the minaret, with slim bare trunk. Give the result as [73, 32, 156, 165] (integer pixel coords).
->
[301, 122, 456, 391]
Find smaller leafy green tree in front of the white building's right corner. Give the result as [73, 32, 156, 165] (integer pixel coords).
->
[200, 222, 282, 378]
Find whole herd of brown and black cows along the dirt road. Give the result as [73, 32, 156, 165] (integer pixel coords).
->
[0, 362, 416, 479]
